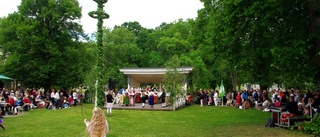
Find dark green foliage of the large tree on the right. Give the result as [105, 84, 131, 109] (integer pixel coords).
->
[194, 0, 319, 88]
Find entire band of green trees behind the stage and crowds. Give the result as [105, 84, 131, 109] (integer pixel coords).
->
[0, 0, 320, 91]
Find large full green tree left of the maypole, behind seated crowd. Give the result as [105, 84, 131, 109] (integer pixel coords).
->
[0, 0, 87, 89]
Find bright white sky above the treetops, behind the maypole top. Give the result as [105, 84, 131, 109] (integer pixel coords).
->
[0, 0, 203, 33]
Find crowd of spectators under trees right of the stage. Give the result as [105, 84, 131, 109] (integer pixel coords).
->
[195, 88, 320, 117]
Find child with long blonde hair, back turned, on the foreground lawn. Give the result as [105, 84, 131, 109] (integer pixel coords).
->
[83, 107, 109, 137]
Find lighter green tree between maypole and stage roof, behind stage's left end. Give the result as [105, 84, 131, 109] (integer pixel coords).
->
[103, 27, 142, 89]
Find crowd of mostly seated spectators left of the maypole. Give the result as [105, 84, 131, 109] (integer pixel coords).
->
[0, 88, 85, 115]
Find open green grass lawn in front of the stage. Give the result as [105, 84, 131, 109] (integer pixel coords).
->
[0, 104, 311, 137]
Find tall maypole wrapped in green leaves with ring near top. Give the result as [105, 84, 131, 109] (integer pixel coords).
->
[89, 0, 109, 108]
